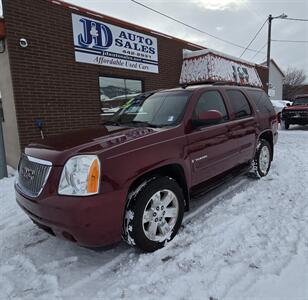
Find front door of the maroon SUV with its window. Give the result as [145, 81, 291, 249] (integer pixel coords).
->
[187, 90, 234, 185]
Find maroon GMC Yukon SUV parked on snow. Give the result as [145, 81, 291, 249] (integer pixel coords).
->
[16, 85, 278, 251]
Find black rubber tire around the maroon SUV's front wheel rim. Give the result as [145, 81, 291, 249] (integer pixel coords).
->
[124, 177, 184, 252]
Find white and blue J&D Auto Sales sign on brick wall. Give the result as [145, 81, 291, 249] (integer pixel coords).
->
[72, 14, 158, 73]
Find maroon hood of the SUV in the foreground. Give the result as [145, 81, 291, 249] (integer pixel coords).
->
[25, 126, 157, 165]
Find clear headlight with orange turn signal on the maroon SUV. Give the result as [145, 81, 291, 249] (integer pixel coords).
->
[58, 155, 101, 196]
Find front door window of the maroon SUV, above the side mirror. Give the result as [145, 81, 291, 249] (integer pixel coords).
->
[193, 91, 229, 121]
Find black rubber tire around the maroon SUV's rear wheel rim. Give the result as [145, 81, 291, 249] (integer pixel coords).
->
[249, 139, 272, 179]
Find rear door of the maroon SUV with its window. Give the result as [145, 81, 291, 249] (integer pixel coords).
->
[225, 89, 257, 166]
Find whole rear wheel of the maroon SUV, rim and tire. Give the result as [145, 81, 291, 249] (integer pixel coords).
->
[249, 139, 272, 178]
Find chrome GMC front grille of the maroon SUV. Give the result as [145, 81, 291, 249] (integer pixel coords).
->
[17, 154, 52, 197]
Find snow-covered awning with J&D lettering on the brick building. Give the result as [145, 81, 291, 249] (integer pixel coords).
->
[180, 49, 262, 87]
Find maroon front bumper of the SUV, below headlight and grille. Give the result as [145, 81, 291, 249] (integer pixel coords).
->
[16, 190, 126, 247]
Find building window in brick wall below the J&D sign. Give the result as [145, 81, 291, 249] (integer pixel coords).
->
[99, 77, 142, 102]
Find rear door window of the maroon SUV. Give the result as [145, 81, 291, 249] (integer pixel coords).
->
[226, 90, 251, 119]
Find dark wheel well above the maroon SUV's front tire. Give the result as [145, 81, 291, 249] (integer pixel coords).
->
[127, 164, 190, 211]
